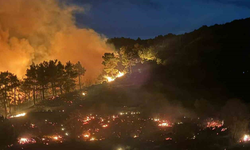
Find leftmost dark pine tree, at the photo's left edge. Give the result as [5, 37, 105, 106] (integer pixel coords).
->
[0, 71, 19, 118]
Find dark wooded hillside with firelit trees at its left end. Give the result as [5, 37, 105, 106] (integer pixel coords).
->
[105, 18, 250, 100]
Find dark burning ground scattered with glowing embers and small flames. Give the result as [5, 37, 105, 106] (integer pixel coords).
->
[1, 83, 249, 150]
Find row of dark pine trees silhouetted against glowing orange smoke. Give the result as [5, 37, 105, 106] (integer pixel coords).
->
[0, 60, 86, 117]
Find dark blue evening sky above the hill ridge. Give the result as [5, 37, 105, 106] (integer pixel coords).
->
[70, 0, 250, 39]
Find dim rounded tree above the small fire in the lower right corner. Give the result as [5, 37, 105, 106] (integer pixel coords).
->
[221, 99, 249, 141]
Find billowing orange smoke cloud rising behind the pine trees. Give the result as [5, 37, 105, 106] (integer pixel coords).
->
[0, 0, 111, 80]
